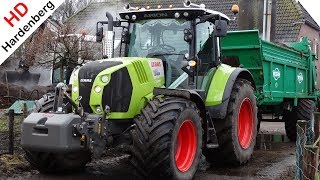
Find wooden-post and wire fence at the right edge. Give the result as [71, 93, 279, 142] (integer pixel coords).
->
[295, 112, 320, 180]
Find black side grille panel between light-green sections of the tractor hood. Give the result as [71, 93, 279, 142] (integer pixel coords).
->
[102, 68, 132, 112]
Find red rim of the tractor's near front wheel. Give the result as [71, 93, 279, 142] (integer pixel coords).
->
[175, 120, 197, 172]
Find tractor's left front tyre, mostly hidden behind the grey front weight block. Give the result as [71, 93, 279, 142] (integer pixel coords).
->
[25, 93, 91, 173]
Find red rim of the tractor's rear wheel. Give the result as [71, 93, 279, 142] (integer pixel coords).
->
[238, 98, 254, 149]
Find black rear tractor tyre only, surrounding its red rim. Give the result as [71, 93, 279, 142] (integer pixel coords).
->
[204, 79, 258, 166]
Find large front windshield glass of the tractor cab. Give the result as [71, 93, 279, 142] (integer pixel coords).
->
[128, 19, 190, 62]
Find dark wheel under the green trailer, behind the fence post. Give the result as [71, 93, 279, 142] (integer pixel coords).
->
[282, 99, 315, 141]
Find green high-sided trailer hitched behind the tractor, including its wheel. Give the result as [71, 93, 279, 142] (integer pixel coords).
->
[222, 31, 319, 141]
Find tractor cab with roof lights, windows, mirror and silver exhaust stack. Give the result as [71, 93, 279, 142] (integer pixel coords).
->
[97, 1, 236, 89]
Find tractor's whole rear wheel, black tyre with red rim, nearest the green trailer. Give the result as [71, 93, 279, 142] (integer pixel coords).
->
[205, 79, 258, 165]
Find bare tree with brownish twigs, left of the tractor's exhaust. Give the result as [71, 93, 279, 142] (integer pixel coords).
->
[25, 22, 101, 83]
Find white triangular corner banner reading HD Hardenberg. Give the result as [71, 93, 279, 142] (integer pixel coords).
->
[0, 0, 64, 64]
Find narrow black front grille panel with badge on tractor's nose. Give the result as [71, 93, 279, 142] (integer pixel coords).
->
[78, 61, 122, 113]
